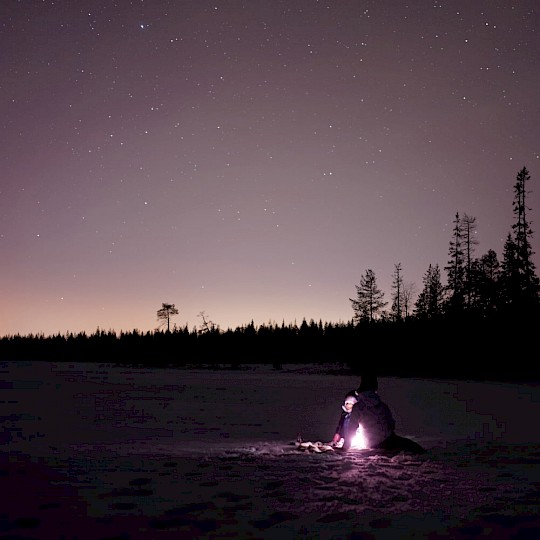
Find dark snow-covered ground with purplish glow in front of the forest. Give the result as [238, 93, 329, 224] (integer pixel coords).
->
[0, 362, 540, 540]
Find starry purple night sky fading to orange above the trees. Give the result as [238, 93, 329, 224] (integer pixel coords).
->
[0, 0, 540, 335]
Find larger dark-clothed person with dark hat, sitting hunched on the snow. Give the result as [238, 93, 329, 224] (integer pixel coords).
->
[342, 374, 426, 454]
